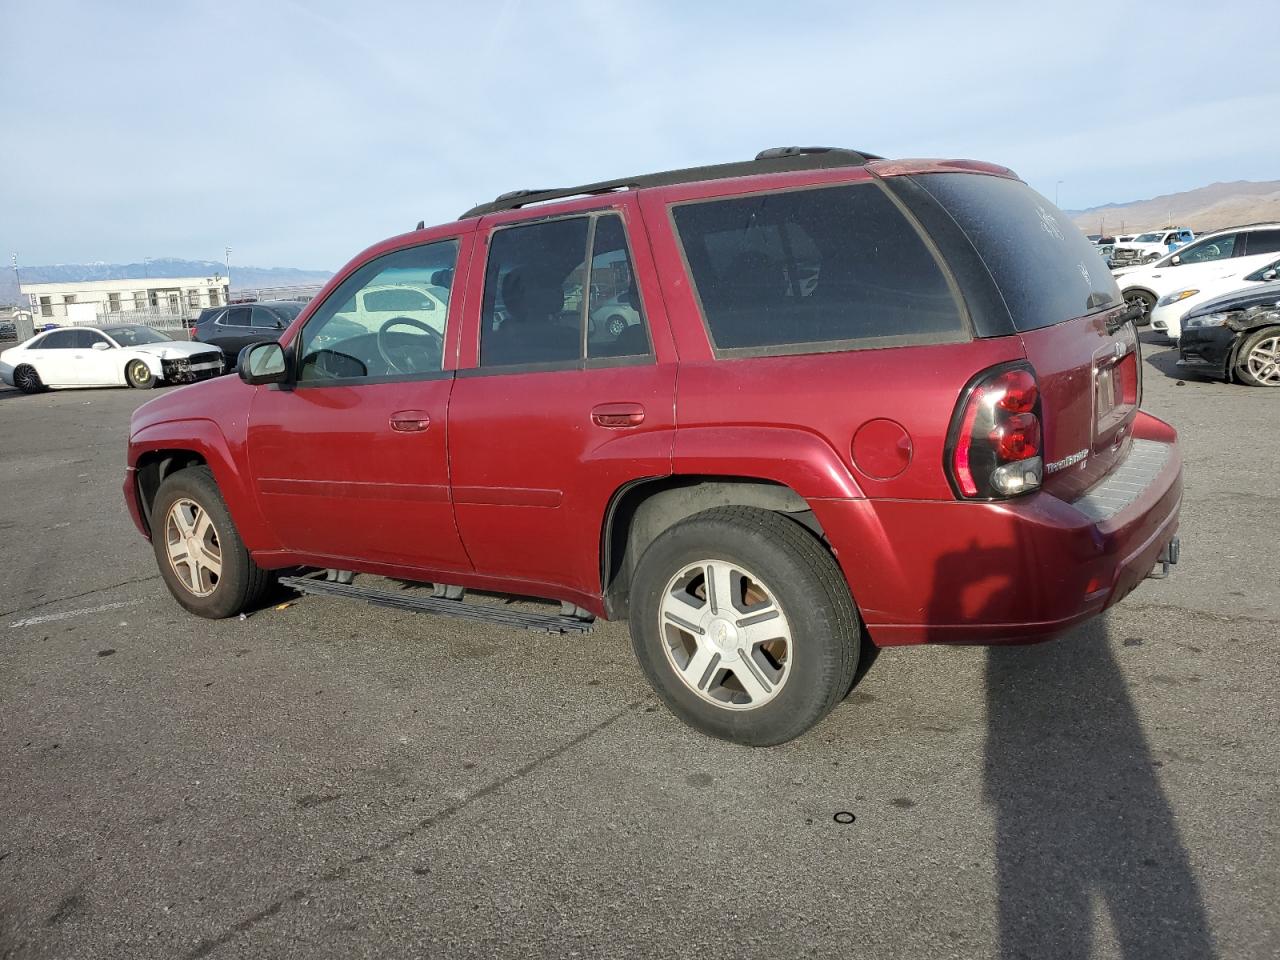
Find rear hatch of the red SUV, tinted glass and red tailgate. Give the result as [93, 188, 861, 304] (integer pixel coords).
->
[910, 173, 1142, 500]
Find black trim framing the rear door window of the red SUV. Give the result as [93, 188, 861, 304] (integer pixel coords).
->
[473, 206, 658, 379]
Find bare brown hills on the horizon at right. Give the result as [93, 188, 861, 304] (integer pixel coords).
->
[1066, 180, 1280, 234]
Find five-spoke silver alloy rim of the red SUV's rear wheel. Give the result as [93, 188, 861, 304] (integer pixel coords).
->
[659, 559, 792, 710]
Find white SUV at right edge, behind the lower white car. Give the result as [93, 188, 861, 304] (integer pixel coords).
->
[1112, 223, 1280, 316]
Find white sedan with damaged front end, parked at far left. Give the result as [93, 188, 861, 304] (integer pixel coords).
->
[0, 324, 223, 393]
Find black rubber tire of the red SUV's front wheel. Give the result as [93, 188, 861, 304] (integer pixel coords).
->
[151, 466, 271, 620]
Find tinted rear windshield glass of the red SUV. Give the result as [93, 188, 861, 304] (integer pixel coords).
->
[914, 173, 1120, 332]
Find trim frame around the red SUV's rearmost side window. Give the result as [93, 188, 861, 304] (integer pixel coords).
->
[667, 177, 975, 360]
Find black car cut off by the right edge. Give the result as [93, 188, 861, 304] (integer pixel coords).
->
[1178, 288, 1280, 387]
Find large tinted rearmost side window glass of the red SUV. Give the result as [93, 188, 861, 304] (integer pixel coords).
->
[672, 183, 968, 356]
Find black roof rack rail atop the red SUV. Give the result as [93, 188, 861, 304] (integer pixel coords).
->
[458, 147, 884, 220]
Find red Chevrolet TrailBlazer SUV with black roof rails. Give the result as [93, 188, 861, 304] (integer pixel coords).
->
[124, 147, 1181, 745]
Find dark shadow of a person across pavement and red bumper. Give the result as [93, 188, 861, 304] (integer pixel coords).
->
[931, 547, 1213, 960]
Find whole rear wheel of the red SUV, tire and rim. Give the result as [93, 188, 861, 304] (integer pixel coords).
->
[631, 507, 860, 746]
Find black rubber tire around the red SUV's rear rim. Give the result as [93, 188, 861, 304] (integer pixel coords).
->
[630, 507, 861, 746]
